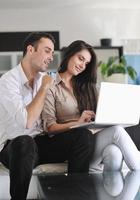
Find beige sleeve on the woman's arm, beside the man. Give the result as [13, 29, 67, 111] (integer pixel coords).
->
[42, 88, 56, 131]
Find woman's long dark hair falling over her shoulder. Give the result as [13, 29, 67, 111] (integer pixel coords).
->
[58, 40, 97, 113]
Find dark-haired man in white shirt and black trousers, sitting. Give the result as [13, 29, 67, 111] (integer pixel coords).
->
[0, 32, 90, 200]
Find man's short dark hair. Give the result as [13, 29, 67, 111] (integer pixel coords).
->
[23, 32, 55, 56]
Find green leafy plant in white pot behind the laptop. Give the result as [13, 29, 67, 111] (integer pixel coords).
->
[99, 56, 137, 83]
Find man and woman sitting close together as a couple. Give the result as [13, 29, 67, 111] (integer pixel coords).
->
[0, 32, 140, 200]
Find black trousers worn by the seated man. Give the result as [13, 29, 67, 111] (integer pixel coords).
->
[0, 129, 94, 200]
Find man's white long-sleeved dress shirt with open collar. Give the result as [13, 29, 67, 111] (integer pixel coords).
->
[0, 64, 42, 151]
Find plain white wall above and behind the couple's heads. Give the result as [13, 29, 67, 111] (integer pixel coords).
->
[0, 0, 140, 47]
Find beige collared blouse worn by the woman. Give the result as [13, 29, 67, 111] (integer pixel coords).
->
[42, 74, 80, 131]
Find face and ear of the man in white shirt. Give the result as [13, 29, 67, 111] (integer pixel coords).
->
[30, 38, 54, 72]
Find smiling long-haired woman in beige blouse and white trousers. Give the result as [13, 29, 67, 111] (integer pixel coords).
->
[43, 40, 140, 171]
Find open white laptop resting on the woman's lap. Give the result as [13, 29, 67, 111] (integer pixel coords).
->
[71, 82, 140, 128]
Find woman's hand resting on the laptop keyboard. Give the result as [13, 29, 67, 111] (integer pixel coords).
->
[78, 110, 95, 123]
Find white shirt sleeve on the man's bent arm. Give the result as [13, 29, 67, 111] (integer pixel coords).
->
[0, 76, 27, 128]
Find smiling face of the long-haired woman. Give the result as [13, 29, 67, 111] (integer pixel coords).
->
[67, 49, 91, 76]
